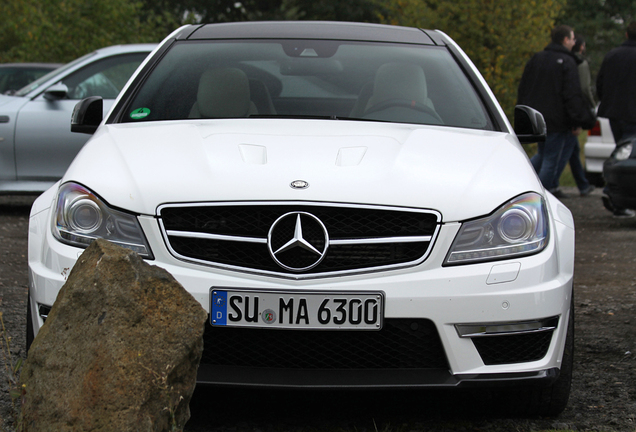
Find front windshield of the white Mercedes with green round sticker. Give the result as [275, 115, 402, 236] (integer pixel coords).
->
[120, 40, 492, 129]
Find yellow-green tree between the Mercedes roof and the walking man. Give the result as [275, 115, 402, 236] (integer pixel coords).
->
[376, 0, 565, 117]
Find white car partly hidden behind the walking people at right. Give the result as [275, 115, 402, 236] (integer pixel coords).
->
[584, 117, 616, 186]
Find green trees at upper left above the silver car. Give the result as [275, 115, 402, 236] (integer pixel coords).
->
[0, 0, 171, 62]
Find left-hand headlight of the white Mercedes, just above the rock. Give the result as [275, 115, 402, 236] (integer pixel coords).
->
[53, 183, 152, 258]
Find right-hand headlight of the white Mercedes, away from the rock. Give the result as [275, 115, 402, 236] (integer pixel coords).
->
[444, 193, 548, 265]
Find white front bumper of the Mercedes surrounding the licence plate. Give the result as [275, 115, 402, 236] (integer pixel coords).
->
[29, 190, 574, 388]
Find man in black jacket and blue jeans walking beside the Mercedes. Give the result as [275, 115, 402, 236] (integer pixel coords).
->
[517, 25, 592, 197]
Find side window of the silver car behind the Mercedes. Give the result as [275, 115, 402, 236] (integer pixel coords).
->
[62, 53, 148, 99]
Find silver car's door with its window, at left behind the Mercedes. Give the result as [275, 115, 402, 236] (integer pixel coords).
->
[15, 52, 148, 181]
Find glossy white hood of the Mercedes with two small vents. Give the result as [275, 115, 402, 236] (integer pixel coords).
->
[63, 119, 543, 221]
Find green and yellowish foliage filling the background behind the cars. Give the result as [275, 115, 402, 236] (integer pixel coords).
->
[0, 0, 636, 117]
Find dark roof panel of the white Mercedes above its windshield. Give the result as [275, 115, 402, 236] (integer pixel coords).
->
[177, 21, 444, 45]
